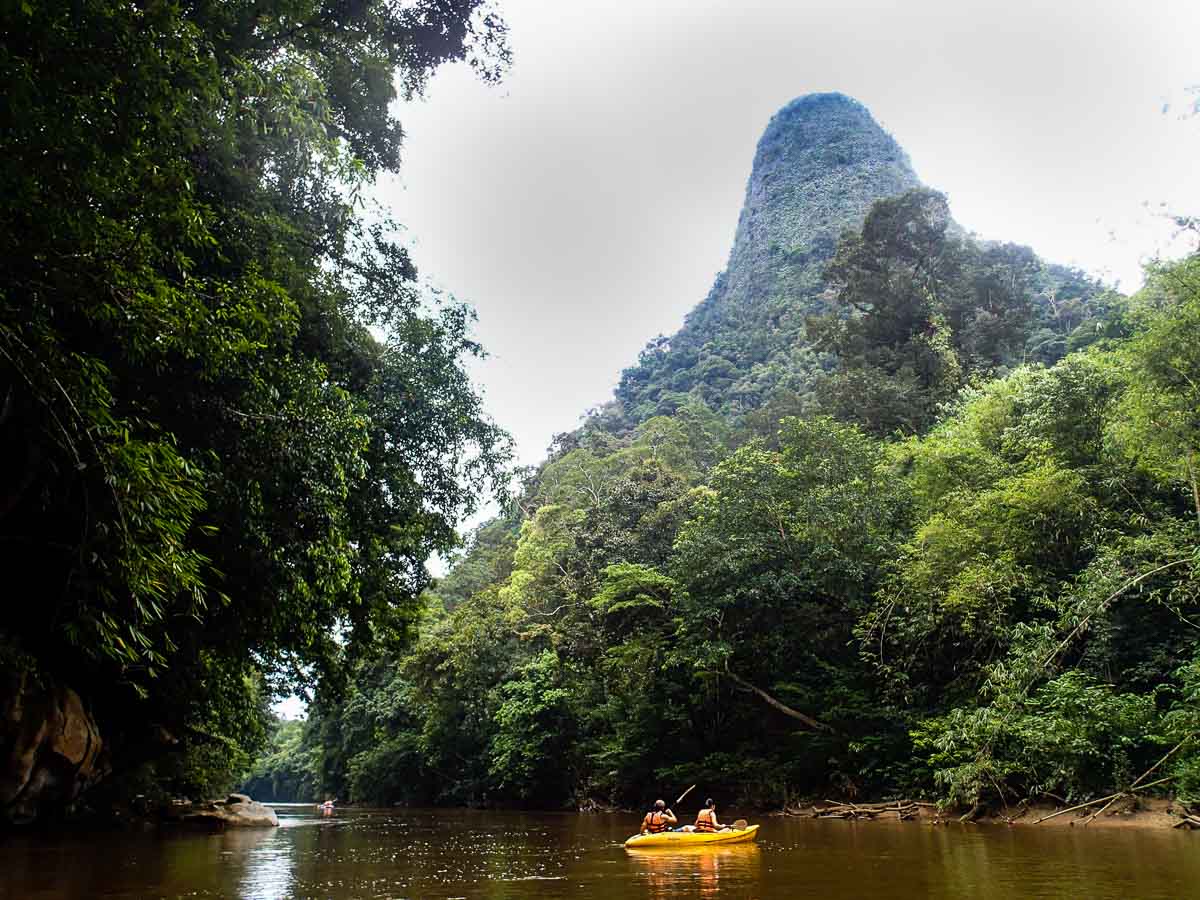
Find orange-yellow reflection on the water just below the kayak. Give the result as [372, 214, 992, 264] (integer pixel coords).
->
[625, 844, 762, 896]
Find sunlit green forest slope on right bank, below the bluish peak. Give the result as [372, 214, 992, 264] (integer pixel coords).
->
[260, 191, 1200, 806]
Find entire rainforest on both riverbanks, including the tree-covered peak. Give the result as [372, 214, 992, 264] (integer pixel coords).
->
[0, 0, 1200, 818]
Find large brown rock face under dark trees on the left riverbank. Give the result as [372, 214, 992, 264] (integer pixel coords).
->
[0, 673, 109, 824]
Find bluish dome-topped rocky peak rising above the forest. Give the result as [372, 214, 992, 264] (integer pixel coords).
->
[617, 94, 920, 421]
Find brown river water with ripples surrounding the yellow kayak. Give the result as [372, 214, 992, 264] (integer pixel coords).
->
[0, 806, 1200, 900]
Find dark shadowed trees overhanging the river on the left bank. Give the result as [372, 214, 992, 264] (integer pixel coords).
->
[0, 0, 506, 816]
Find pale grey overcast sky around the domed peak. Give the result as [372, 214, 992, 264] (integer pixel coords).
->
[378, 0, 1200, 472]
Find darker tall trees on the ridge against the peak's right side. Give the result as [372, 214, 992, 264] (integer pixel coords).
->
[810, 190, 1109, 436]
